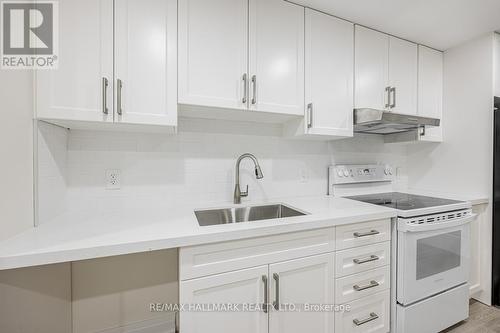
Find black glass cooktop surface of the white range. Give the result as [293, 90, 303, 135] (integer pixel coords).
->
[346, 192, 461, 210]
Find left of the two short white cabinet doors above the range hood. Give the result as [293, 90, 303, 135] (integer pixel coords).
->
[354, 25, 389, 110]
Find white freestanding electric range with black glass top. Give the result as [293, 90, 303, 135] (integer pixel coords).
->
[329, 165, 475, 333]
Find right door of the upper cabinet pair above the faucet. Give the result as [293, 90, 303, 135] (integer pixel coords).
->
[249, 0, 304, 115]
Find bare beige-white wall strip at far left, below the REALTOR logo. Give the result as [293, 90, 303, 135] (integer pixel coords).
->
[0, 70, 34, 240]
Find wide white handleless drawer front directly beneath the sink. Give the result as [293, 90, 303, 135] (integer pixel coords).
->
[179, 228, 335, 280]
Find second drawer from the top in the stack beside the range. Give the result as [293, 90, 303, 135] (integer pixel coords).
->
[335, 242, 391, 278]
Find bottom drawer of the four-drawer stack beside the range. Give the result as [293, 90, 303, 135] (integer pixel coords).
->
[335, 290, 391, 333]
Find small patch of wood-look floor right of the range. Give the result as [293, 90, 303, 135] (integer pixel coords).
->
[441, 301, 500, 333]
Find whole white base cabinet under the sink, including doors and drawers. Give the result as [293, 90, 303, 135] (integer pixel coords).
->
[179, 219, 391, 333]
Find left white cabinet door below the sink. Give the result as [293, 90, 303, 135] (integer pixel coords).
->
[180, 265, 268, 333]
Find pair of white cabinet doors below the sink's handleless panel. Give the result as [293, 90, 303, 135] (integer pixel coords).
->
[180, 254, 334, 333]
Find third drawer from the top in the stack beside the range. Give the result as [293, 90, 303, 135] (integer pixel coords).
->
[335, 266, 391, 304]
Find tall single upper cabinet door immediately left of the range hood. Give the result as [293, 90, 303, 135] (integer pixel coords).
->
[305, 8, 354, 137]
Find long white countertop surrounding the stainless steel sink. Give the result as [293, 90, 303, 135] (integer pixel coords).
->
[0, 196, 397, 270]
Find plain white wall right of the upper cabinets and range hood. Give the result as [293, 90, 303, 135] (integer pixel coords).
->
[408, 33, 494, 303]
